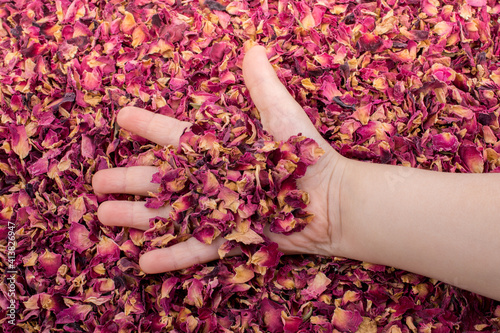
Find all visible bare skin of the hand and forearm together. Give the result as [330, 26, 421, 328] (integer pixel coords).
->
[92, 46, 500, 300]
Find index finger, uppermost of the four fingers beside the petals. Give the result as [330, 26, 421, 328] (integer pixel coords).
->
[117, 106, 191, 146]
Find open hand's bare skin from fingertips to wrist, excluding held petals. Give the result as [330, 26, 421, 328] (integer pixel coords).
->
[92, 46, 347, 273]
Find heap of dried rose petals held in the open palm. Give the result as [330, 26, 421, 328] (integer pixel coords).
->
[146, 105, 324, 253]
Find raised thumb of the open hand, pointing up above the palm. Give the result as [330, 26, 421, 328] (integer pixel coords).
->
[243, 45, 331, 150]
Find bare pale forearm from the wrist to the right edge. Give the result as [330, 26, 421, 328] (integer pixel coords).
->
[339, 161, 500, 299]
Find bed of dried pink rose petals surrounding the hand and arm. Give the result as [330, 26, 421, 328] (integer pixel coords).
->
[0, 0, 500, 332]
